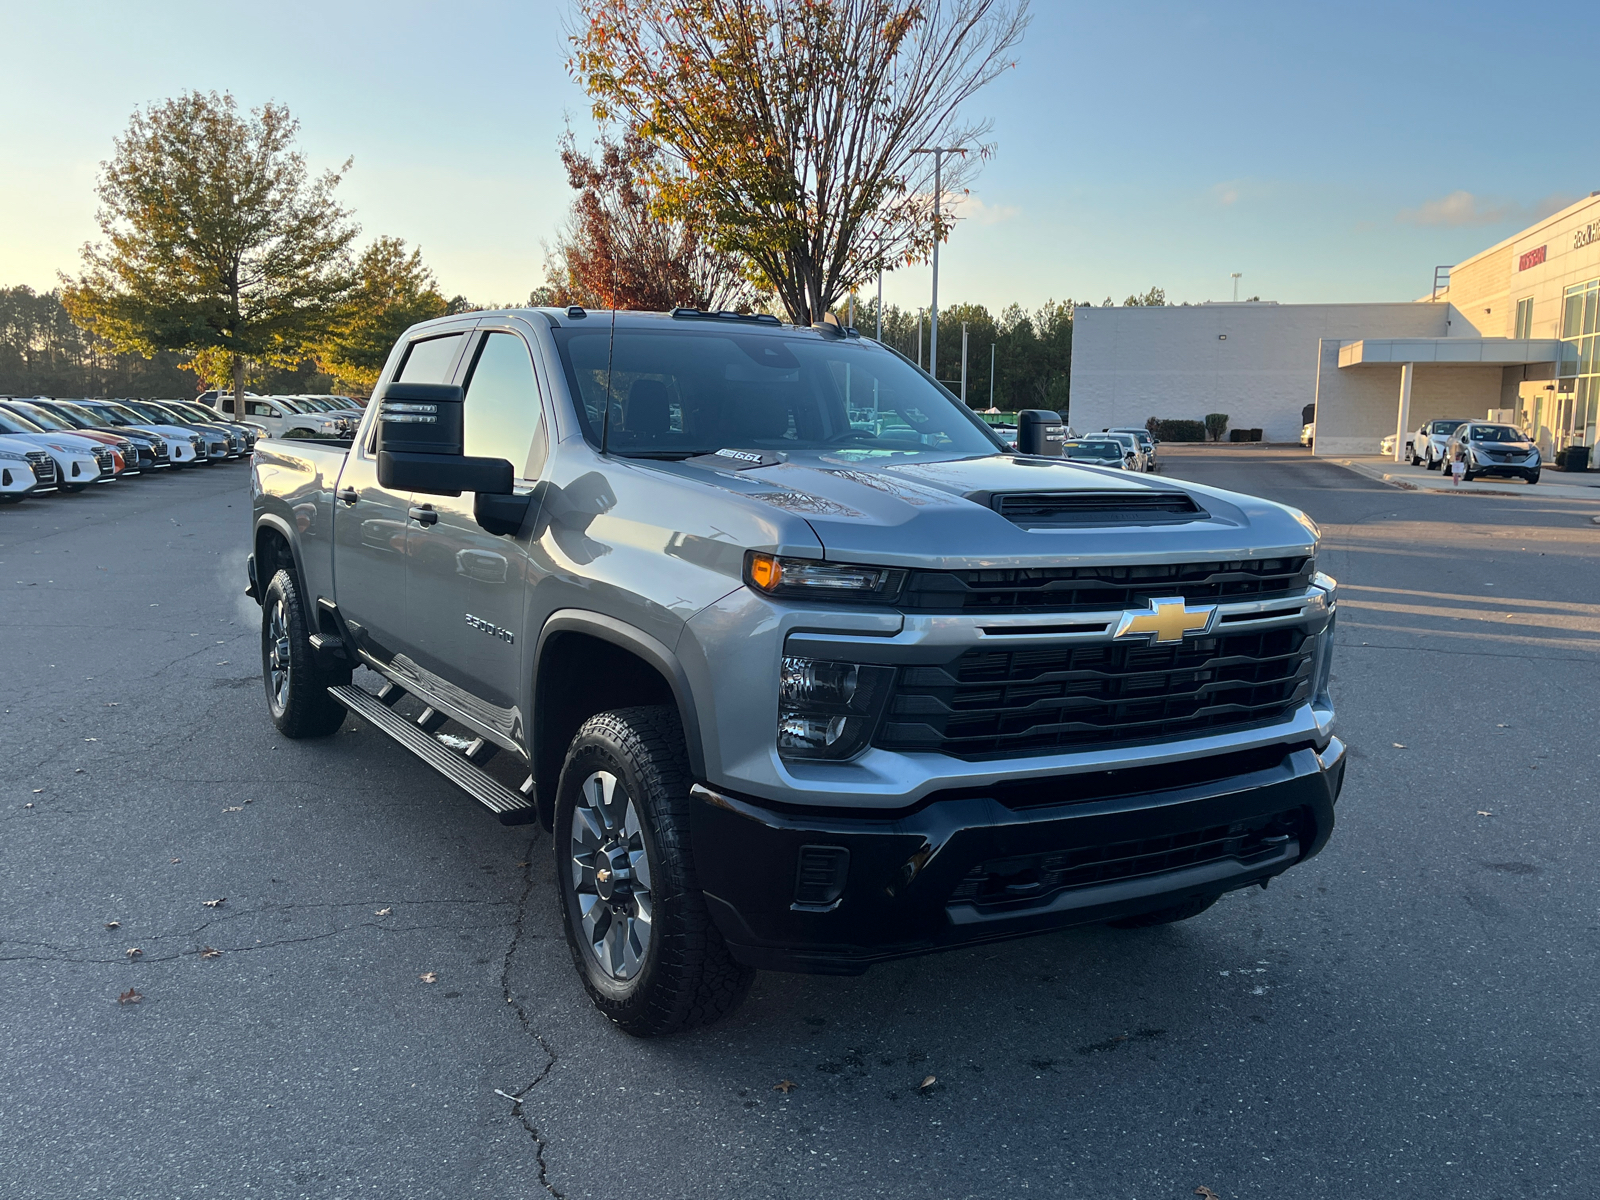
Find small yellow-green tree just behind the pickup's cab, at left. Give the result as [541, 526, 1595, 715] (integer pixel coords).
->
[317, 237, 464, 392]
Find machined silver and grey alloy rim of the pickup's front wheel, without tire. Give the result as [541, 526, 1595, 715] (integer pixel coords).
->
[570, 771, 653, 981]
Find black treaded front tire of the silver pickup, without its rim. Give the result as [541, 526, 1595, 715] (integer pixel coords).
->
[552, 706, 755, 1037]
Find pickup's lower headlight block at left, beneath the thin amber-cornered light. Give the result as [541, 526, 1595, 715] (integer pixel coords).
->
[778, 656, 894, 760]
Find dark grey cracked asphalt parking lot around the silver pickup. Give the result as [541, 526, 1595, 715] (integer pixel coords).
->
[0, 446, 1600, 1200]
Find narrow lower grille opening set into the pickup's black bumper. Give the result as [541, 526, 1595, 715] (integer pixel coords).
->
[949, 808, 1307, 909]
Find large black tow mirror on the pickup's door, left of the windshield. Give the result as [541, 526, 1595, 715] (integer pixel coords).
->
[378, 384, 515, 496]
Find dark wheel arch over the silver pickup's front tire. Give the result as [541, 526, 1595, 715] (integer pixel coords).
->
[528, 610, 706, 827]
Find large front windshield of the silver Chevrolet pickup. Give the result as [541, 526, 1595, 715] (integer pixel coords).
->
[555, 326, 1000, 461]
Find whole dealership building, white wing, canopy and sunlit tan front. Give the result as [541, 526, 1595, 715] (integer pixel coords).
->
[1070, 192, 1600, 466]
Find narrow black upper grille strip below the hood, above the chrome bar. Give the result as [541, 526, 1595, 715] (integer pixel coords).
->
[901, 557, 1315, 613]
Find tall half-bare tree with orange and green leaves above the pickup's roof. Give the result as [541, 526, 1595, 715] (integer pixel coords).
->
[568, 0, 1027, 325]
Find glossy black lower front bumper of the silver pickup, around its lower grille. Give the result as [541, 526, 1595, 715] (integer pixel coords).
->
[691, 739, 1346, 974]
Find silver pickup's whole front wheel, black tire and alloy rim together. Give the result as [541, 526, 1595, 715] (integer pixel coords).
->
[554, 707, 755, 1037]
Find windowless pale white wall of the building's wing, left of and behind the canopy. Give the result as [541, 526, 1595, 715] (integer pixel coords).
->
[1070, 302, 1452, 453]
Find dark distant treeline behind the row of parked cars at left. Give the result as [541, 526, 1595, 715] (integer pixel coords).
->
[0, 286, 331, 397]
